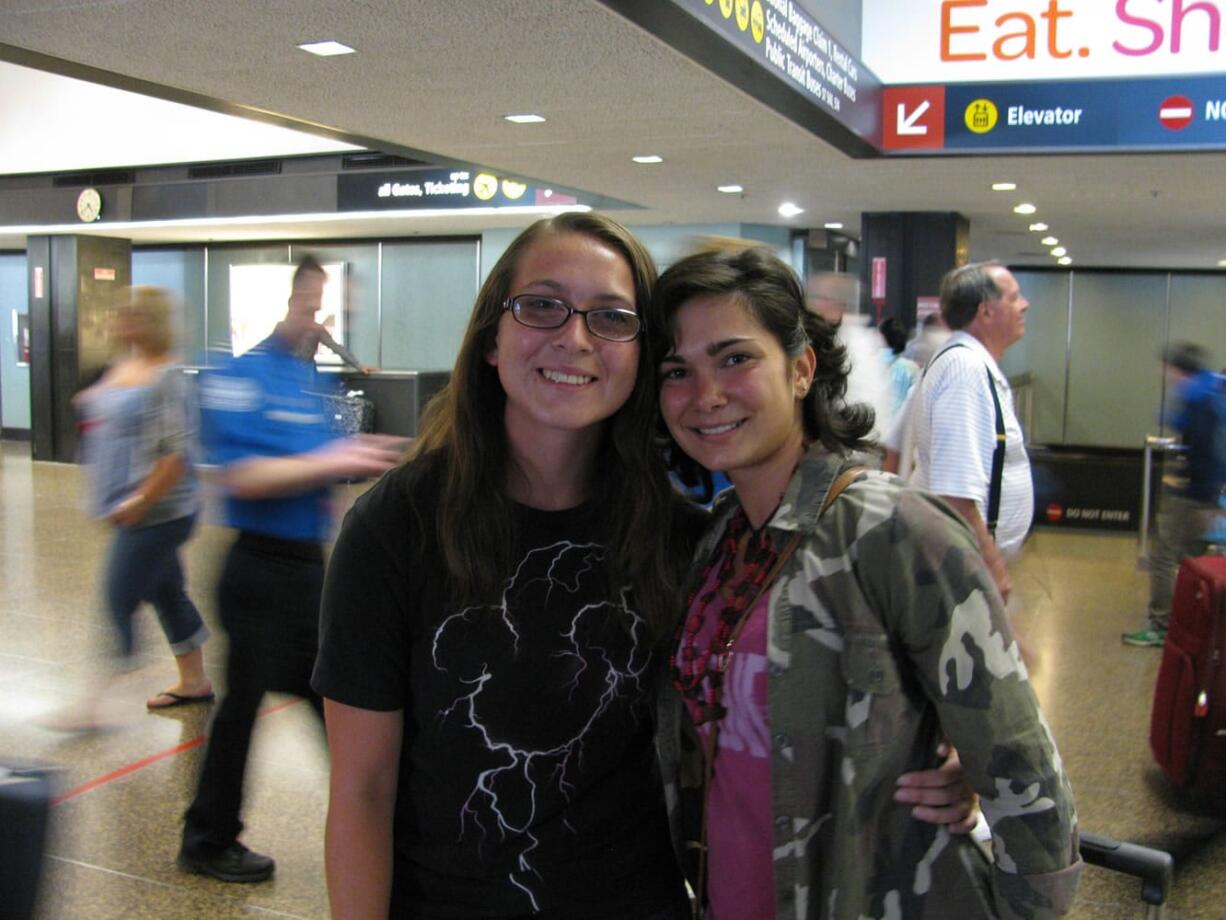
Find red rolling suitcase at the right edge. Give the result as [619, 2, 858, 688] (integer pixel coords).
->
[1150, 556, 1226, 795]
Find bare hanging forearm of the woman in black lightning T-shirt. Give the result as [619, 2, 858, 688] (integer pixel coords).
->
[324, 699, 405, 920]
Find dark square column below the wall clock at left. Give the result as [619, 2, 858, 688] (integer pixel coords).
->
[26, 236, 132, 462]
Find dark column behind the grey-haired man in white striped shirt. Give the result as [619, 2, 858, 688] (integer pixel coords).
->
[859, 211, 971, 329]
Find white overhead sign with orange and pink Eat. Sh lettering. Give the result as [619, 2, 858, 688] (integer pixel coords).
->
[861, 0, 1226, 85]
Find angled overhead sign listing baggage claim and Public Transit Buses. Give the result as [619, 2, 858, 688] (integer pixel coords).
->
[602, 0, 881, 155]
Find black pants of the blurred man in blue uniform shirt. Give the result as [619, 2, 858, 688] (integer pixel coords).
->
[183, 531, 324, 857]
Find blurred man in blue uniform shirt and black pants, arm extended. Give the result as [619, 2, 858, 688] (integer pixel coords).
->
[178, 258, 402, 882]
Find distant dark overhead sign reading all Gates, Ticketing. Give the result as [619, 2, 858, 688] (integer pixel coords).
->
[336, 169, 576, 211]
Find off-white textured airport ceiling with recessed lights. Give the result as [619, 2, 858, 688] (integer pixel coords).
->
[0, 0, 1226, 269]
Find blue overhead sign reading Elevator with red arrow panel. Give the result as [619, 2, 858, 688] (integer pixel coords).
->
[881, 75, 1226, 153]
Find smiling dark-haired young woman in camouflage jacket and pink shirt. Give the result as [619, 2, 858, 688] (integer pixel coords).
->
[649, 249, 1080, 920]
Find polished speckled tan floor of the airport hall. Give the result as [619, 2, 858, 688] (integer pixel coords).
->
[0, 443, 1226, 920]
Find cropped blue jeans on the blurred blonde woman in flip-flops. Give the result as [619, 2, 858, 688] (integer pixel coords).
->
[103, 514, 208, 661]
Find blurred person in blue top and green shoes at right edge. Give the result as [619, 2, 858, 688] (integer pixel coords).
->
[1121, 342, 1226, 646]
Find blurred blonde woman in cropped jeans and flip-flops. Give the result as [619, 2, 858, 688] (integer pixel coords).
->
[48, 287, 213, 729]
